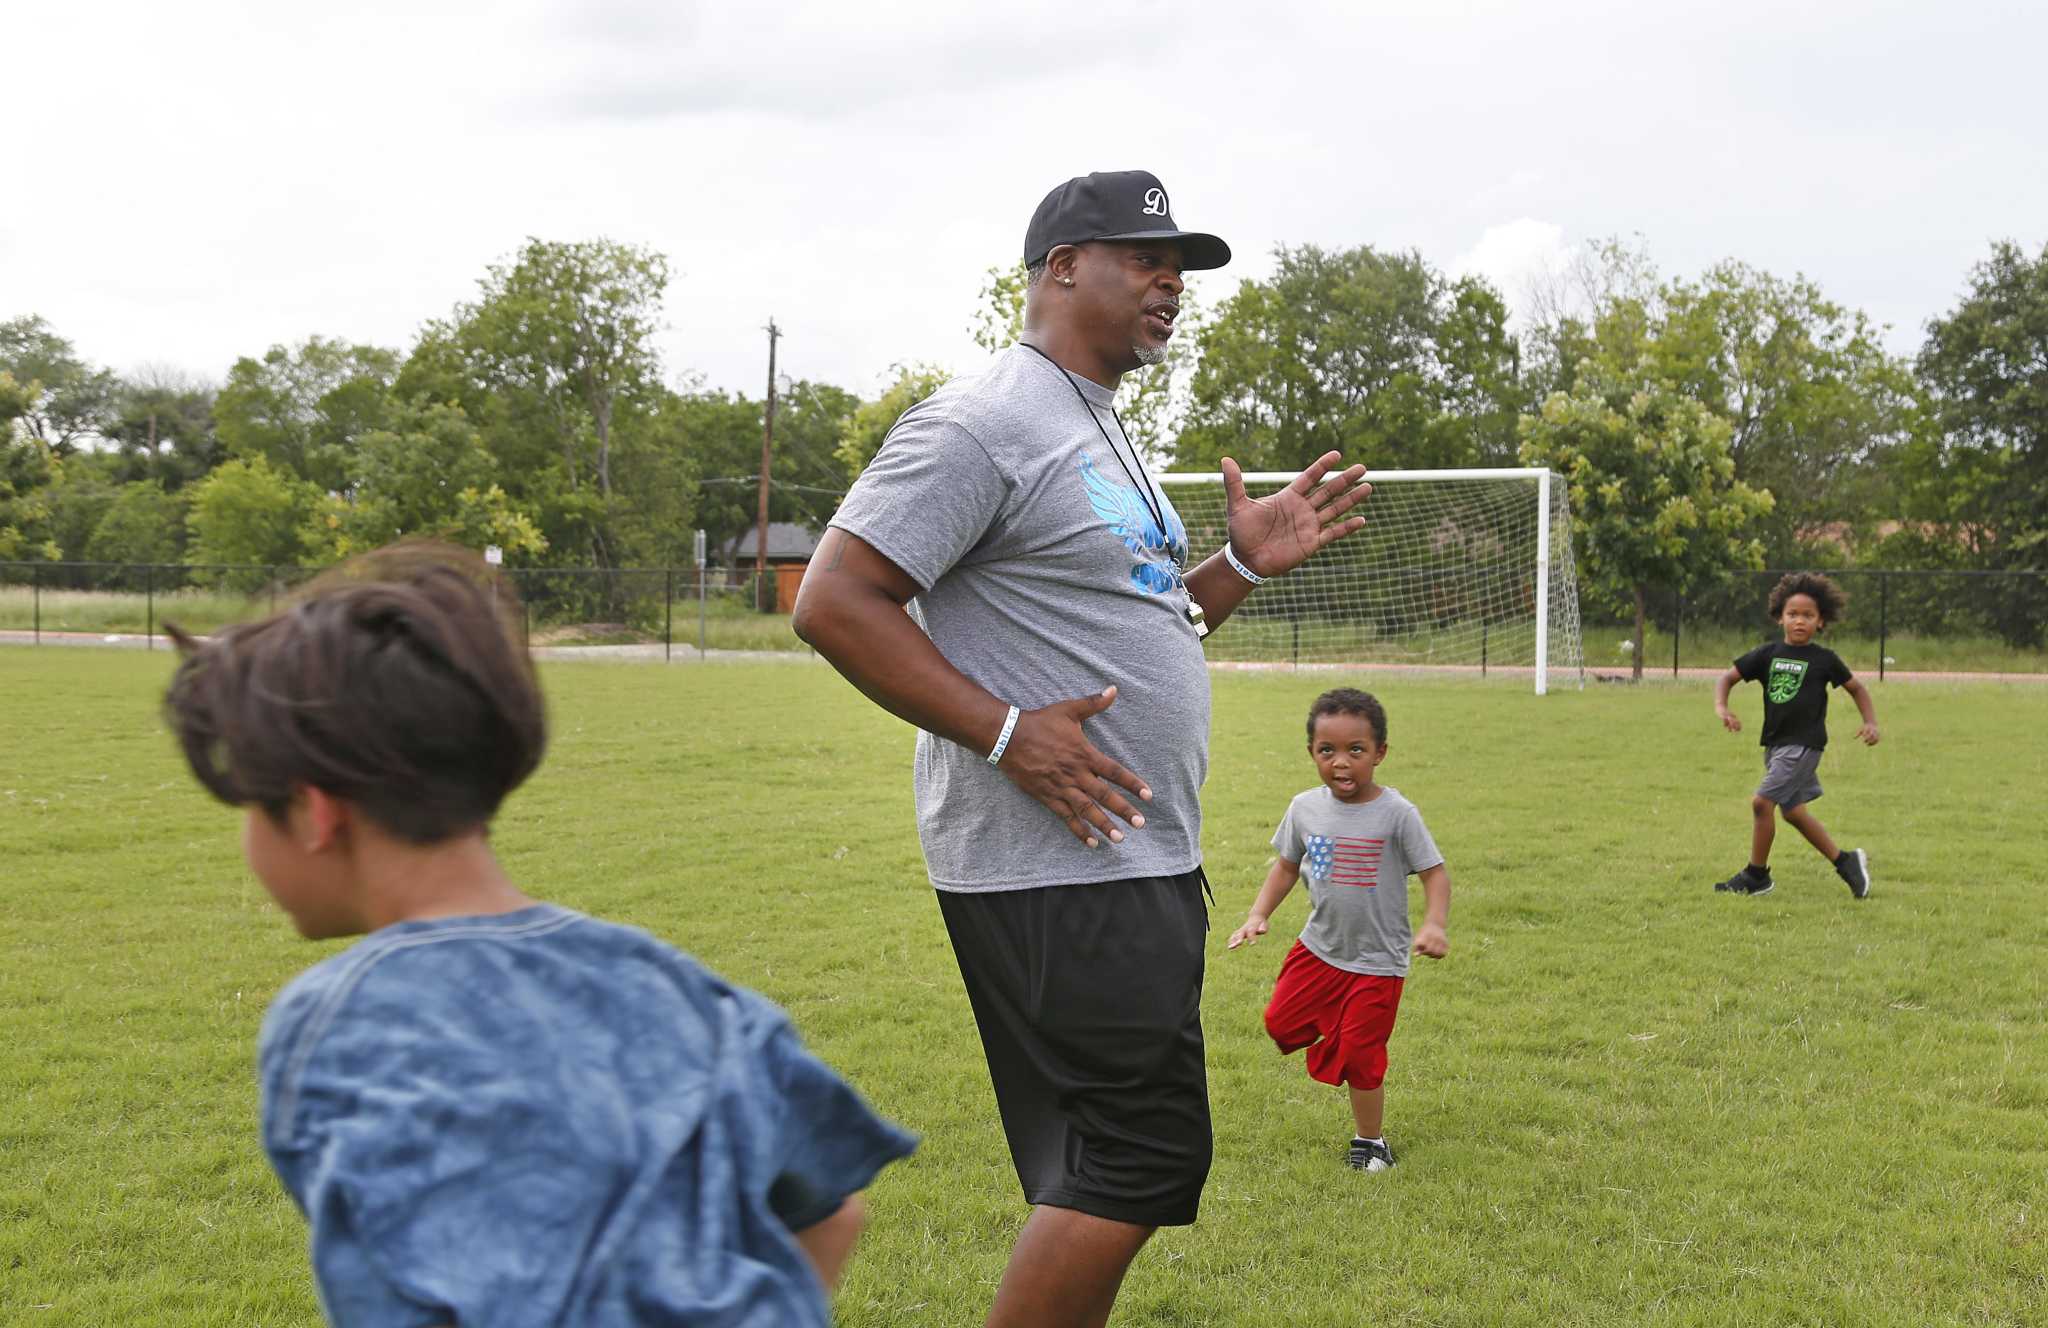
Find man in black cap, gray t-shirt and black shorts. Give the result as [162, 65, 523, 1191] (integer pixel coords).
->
[795, 170, 1372, 1328]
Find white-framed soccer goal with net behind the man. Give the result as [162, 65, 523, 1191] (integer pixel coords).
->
[1159, 469, 1585, 695]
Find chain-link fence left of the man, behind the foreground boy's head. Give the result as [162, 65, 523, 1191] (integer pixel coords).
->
[0, 562, 807, 658]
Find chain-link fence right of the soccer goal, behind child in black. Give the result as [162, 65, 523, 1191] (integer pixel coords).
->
[1585, 568, 2048, 678]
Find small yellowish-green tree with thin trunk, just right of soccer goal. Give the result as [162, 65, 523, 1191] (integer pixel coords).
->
[1522, 357, 1772, 678]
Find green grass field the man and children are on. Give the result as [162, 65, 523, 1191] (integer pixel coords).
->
[0, 648, 2048, 1328]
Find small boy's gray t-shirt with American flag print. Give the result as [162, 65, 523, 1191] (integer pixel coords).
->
[1274, 785, 1444, 978]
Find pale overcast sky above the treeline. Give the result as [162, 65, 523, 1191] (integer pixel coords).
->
[0, 0, 2048, 396]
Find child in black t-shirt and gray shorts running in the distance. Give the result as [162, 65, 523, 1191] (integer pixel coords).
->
[1714, 572, 1878, 900]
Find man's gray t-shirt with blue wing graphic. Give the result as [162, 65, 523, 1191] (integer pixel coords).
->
[831, 346, 1208, 889]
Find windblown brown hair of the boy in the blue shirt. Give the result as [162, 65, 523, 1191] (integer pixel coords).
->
[164, 543, 547, 844]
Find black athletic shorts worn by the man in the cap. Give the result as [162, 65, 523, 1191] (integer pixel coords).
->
[938, 867, 1212, 1226]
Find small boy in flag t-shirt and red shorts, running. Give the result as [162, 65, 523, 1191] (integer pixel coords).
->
[1227, 687, 1450, 1172]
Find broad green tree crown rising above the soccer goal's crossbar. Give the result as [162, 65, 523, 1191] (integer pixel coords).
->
[1174, 244, 1524, 469]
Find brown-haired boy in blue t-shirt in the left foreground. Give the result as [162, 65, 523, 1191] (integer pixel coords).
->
[166, 545, 913, 1328]
